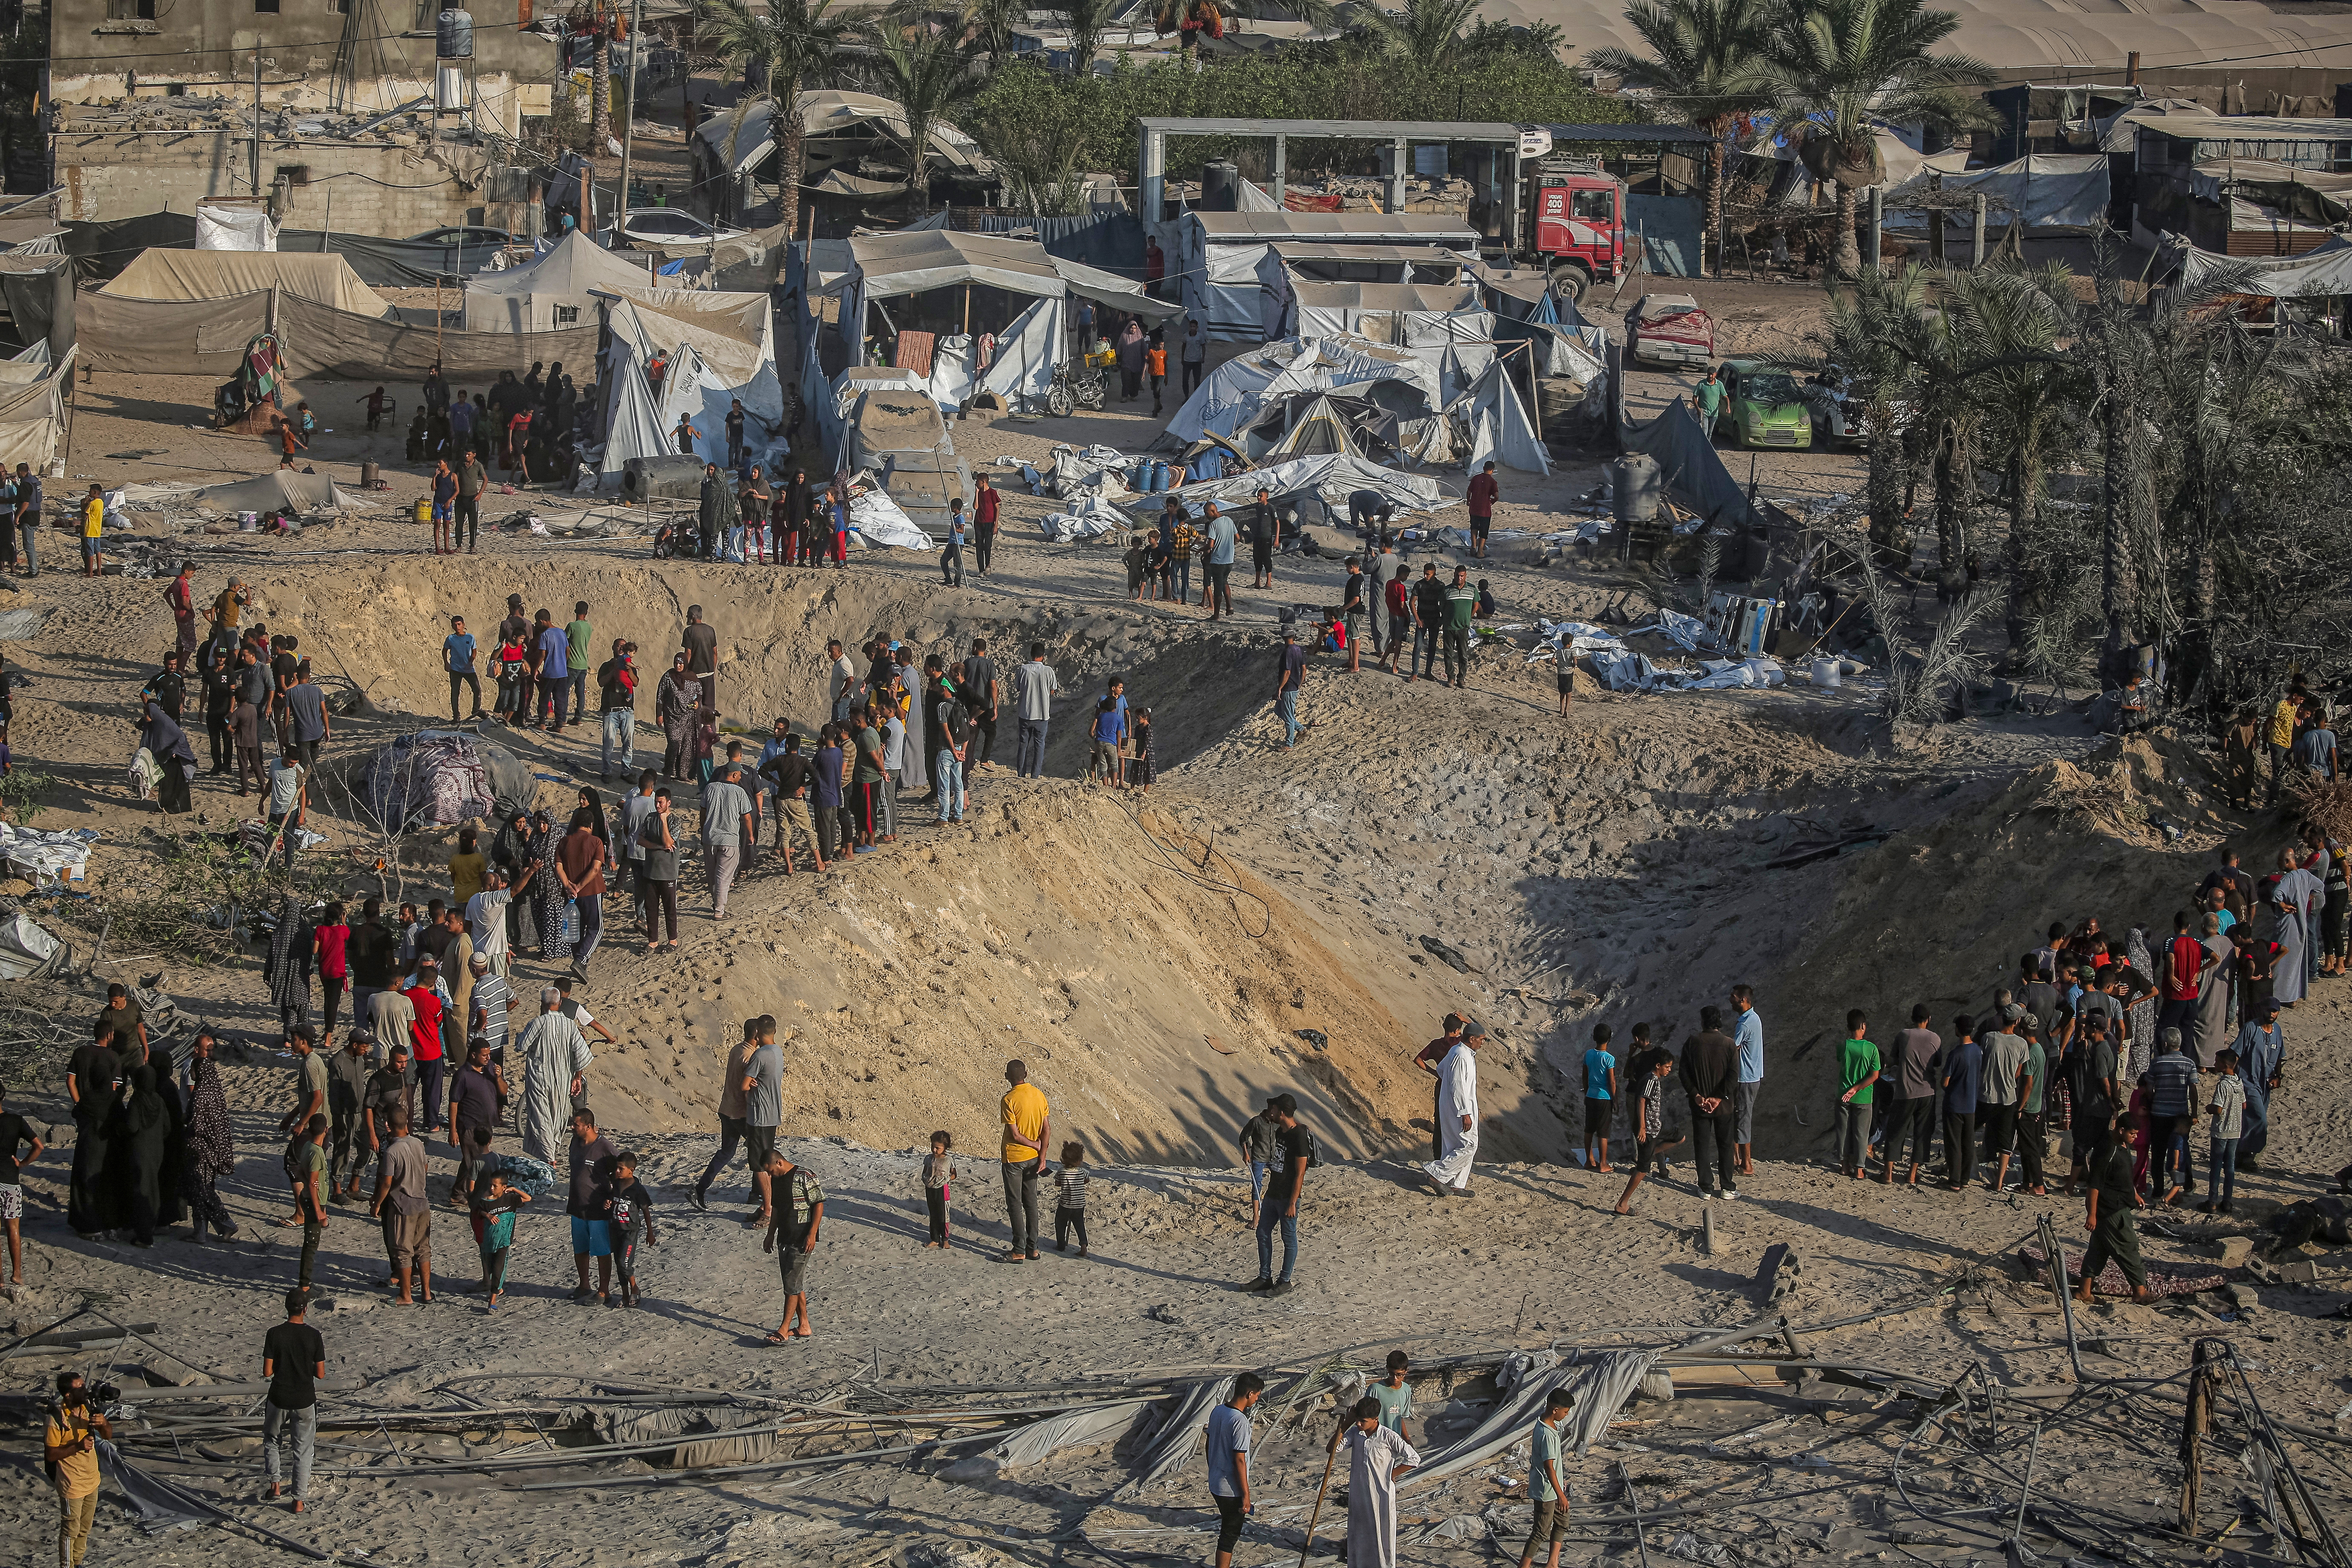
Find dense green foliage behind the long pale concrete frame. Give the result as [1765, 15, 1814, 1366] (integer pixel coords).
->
[976, 45, 1642, 172]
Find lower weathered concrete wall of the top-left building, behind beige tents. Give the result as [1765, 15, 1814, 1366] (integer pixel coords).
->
[52, 132, 527, 240]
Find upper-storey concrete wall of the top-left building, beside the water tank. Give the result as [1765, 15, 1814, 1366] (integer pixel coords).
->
[49, 0, 557, 136]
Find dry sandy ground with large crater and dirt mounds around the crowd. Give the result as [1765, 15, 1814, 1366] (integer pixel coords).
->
[0, 276, 2352, 1565]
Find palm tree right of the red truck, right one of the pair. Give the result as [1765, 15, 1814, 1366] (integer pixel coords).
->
[1755, 0, 1992, 277]
